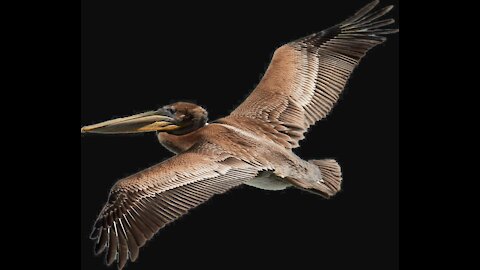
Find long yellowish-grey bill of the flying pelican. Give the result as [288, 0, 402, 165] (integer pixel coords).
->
[81, 110, 180, 134]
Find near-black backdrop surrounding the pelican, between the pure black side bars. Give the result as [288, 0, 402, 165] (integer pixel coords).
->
[80, 0, 399, 269]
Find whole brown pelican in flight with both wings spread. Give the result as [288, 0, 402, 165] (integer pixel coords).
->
[81, 1, 397, 269]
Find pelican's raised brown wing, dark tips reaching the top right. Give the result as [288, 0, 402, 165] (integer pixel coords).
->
[229, 1, 398, 148]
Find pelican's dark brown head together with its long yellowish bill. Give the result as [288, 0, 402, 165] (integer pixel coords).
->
[81, 102, 208, 135]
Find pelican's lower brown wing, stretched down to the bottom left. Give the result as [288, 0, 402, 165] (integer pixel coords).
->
[91, 144, 267, 269]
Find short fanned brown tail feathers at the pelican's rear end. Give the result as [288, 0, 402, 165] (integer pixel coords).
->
[309, 159, 343, 197]
